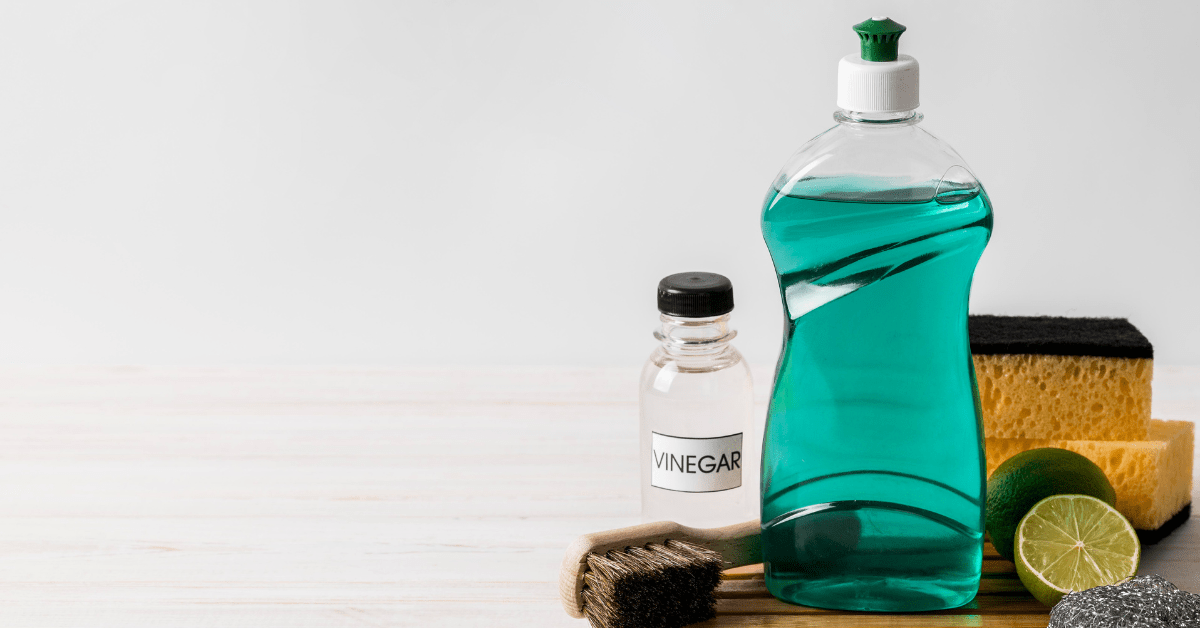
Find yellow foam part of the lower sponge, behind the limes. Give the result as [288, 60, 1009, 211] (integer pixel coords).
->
[985, 422, 1195, 530]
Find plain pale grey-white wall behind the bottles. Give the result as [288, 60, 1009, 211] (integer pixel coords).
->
[0, 0, 1200, 364]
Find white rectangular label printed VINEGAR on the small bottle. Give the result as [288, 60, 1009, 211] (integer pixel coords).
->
[650, 432, 742, 492]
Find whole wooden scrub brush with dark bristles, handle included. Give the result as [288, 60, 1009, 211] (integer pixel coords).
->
[558, 521, 762, 628]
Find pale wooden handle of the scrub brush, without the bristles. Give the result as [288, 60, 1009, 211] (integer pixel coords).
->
[558, 520, 762, 617]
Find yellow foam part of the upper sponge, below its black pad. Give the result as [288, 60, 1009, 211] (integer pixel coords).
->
[974, 353, 1154, 441]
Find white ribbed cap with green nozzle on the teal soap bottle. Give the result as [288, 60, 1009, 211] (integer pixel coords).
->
[838, 17, 920, 113]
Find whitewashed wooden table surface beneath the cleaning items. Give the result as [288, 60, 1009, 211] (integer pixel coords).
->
[0, 366, 1200, 628]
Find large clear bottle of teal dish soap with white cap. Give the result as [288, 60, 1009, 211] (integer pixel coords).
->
[762, 18, 992, 612]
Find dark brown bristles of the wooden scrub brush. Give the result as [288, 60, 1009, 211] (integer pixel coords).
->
[583, 540, 724, 628]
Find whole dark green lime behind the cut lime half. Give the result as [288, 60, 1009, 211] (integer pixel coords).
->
[986, 447, 1117, 561]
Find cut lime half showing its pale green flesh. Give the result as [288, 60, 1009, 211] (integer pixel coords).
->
[1013, 495, 1141, 606]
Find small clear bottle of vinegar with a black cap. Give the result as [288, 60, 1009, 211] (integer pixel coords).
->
[640, 273, 762, 527]
